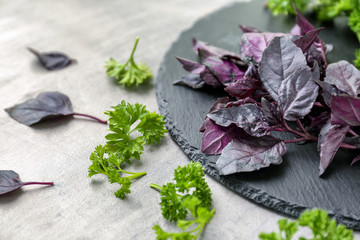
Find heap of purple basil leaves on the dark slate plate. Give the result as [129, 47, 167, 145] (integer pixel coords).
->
[175, 7, 360, 175]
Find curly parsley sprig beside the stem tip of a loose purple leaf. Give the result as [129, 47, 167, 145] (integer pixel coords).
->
[89, 101, 167, 199]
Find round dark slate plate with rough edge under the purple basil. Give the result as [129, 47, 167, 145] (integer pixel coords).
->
[156, 0, 360, 230]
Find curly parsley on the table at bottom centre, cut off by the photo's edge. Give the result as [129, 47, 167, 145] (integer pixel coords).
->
[150, 162, 215, 240]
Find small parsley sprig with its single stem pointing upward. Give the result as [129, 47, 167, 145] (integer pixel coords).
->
[105, 37, 152, 87]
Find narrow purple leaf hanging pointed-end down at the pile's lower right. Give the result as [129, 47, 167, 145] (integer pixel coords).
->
[318, 120, 350, 175]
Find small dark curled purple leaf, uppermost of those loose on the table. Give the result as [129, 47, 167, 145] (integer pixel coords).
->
[28, 48, 76, 70]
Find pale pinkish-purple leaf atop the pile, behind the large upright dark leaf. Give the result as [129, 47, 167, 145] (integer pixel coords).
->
[240, 32, 285, 62]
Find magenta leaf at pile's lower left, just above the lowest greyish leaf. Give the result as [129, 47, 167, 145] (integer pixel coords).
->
[201, 119, 245, 155]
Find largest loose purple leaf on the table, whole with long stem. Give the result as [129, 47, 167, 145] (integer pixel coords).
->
[5, 92, 107, 126]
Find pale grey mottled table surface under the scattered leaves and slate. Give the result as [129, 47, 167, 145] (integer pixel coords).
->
[0, 0, 360, 240]
